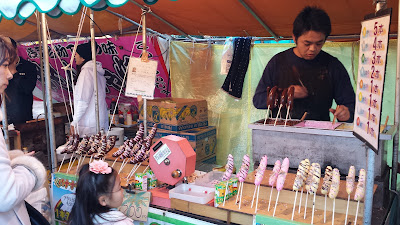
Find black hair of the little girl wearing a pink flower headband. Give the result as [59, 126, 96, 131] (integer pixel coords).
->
[68, 164, 118, 225]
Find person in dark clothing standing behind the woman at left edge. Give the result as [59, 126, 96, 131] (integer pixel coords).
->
[5, 38, 39, 124]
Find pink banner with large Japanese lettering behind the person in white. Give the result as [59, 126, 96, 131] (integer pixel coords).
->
[18, 36, 171, 110]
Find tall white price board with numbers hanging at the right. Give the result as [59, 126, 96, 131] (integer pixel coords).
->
[353, 9, 391, 153]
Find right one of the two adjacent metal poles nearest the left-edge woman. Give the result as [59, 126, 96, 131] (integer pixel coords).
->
[40, 13, 57, 173]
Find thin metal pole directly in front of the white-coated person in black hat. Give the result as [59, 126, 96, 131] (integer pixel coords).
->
[90, 9, 100, 133]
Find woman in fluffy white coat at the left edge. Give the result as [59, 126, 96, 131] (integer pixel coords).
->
[0, 36, 46, 225]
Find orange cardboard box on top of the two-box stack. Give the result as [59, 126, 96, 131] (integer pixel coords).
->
[139, 98, 208, 131]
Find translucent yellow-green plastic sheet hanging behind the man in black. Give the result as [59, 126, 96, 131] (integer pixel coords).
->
[170, 41, 396, 166]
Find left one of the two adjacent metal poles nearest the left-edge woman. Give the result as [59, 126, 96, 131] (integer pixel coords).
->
[36, 10, 50, 168]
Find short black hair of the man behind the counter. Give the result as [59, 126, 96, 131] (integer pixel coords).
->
[293, 6, 331, 40]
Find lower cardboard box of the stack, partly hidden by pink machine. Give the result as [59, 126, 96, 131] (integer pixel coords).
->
[153, 126, 217, 161]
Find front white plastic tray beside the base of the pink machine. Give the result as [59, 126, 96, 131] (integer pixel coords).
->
[169, 184, 214, 204]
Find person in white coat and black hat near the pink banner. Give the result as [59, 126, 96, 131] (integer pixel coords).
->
[71, 42, 108, 136]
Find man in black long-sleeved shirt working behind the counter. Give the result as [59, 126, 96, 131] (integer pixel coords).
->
[253, 6, 355, 122]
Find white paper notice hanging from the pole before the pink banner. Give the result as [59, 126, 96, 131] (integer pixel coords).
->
[125, 57, 158, 99]
